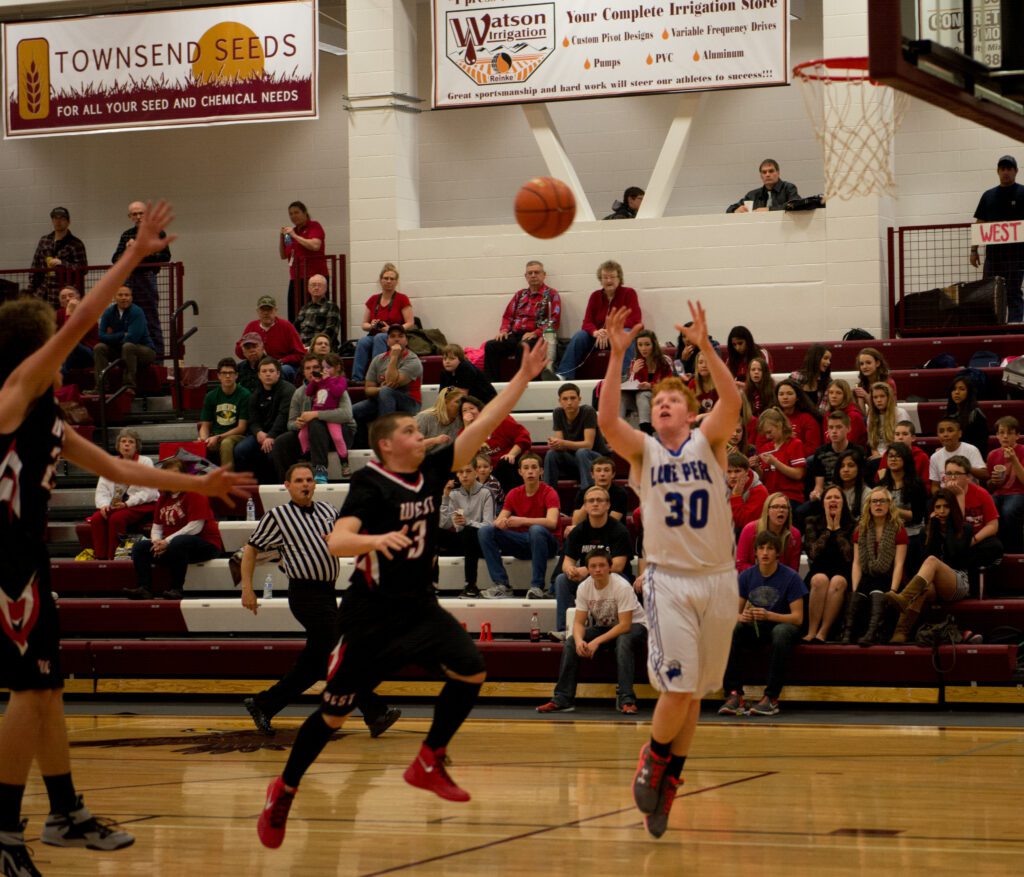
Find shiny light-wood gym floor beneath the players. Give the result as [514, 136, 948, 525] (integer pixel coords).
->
[8, 709, 1024, 877]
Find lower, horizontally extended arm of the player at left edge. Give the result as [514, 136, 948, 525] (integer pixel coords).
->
[63, 429, 257, 506]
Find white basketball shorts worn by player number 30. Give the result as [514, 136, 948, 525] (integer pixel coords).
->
[643, 563, 739, 698]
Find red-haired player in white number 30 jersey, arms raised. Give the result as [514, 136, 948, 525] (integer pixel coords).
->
[598, 302, 739, 837]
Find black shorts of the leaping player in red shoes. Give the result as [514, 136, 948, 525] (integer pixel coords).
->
[321, 595, 485, 715]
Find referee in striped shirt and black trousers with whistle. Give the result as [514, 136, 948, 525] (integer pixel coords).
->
[242, 463, 401, 737]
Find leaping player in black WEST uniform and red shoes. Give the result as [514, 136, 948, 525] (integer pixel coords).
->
[258, 340, 547, 848]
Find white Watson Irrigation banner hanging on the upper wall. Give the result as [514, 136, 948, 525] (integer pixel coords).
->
[432, 0, 790, 109]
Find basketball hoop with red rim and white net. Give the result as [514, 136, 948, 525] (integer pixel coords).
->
[793, 57, 907, 201]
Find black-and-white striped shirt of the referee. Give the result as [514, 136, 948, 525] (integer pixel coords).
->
[249, 500, 341, 583]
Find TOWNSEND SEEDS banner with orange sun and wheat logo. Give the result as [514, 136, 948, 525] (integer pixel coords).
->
[3, 0, 317, 137]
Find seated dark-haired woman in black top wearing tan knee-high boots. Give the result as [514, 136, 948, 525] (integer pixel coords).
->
[886, 488, 974, 643]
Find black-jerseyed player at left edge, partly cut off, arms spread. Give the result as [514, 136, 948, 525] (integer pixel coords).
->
[0, 203, 254, 877]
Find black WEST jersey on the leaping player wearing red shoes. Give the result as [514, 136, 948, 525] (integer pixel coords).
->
[338, 445, 455, 594]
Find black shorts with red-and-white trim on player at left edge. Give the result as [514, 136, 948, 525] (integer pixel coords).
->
[0, 566, 63, 692]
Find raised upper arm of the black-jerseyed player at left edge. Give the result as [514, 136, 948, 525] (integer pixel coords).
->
[0, 201, 174, 432]
